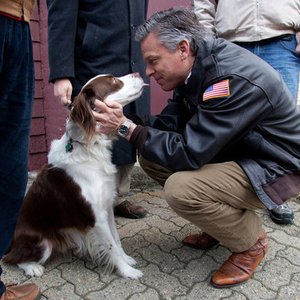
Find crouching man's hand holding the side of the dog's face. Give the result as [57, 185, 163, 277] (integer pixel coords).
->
[93, 100, 126, 134]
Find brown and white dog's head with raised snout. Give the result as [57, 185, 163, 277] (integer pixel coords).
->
[69, 73, 146, 139]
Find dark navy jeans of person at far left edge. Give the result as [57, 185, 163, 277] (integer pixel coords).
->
[0, 15, 34, 296]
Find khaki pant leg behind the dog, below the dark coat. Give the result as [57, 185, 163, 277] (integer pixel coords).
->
[116, 164, 134, 205]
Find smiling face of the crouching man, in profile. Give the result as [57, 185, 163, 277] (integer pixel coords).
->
[141, 32, 191, 91]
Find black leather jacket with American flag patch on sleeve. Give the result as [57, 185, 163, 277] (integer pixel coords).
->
[131, 37, 300, 208]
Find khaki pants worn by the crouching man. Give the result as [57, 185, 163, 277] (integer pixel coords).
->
[139, 158, 265, 252]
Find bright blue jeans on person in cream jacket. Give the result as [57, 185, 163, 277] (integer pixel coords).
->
[236, 35, 300, 102]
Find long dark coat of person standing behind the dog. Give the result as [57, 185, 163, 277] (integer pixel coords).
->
[47, 0, 150, 165]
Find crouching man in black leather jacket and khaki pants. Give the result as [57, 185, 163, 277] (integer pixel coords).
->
[95, 8, 300, 288]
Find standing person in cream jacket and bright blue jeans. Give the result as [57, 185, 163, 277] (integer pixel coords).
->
[193, 0, 300, 224]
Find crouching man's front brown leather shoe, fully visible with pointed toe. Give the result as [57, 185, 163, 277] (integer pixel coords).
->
[211, 232, 269, 288]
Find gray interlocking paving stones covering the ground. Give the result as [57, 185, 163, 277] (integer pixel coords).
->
[3, 166, 300, 300]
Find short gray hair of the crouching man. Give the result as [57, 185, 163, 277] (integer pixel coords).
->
[135, 7, 207, 54]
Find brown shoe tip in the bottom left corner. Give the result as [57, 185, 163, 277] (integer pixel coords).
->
[0, 283, 41, 300]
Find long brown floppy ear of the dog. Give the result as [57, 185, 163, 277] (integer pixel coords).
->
[70, 91, 96, 140]
